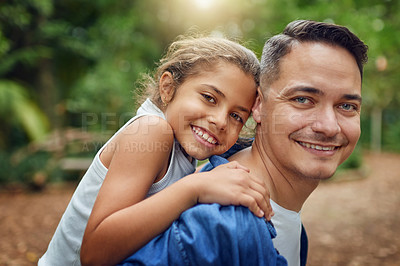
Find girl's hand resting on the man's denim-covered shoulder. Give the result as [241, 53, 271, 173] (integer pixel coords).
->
[189, 161, 274, 220]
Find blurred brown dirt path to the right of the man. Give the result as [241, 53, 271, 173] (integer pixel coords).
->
[302, 154, 400, 266]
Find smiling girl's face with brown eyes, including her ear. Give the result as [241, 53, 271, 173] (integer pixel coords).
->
[160, 62, 257, 160]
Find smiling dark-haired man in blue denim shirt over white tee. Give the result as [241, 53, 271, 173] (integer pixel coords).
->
[117, 21, 367, 265]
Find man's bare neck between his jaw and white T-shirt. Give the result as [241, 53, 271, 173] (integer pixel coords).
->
[229, 138, 319, 212]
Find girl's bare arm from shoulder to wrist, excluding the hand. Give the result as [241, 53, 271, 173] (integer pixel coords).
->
[81, 116, 183, 265]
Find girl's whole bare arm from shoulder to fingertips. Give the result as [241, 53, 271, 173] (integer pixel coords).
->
[81, 118, 270, 265]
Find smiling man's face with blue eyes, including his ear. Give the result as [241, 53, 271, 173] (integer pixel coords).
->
[254, 42, 361, 179]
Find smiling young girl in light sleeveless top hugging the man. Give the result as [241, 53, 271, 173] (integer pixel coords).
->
[39, 37, 271, 265]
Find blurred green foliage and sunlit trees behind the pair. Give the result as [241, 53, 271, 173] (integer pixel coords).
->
[0, 0, 400, 186]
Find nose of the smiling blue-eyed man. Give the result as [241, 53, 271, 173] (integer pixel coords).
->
[311, 108, 341, 137]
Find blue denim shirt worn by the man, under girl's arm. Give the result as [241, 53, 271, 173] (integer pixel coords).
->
[119, 156, 287, 266]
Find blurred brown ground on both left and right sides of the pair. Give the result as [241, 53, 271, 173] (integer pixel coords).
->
[0, 153, 400, 266]
